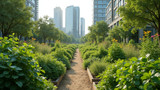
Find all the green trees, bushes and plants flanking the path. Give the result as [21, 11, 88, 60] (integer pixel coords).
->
[0, 0, 160, 90]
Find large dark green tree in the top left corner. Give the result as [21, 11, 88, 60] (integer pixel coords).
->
[0, 0, 33, 37]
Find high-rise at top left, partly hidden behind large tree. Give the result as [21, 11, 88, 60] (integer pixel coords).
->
[26, 0, 38, 21]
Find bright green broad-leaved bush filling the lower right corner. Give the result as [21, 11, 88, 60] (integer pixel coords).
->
[116, 58, 160, 90]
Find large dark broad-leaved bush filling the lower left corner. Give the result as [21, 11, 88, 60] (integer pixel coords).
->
[0, 36, 55, 90]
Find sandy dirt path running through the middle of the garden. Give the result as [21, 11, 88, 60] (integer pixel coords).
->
[58, 49, 92, 90]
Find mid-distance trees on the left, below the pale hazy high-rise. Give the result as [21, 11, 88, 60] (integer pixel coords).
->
[35, 16, 72, 43]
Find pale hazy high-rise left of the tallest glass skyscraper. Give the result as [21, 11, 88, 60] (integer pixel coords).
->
[54, 7, 63, 30]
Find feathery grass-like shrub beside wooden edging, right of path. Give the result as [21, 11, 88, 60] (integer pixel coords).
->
[89, 61, 107, 76]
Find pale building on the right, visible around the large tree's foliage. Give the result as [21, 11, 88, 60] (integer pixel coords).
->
[106, 0, 156, 42]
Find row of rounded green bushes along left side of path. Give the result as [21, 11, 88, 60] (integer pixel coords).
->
[36, 42, 77, 80]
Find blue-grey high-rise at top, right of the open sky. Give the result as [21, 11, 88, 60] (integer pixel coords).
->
[93, 0, 110, 24]
